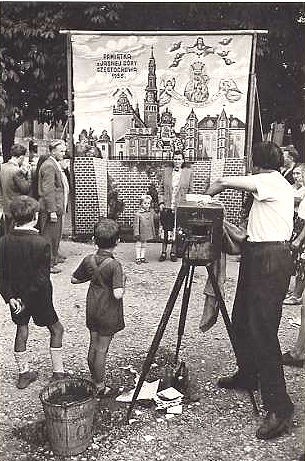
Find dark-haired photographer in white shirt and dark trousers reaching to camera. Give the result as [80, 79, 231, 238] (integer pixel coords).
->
[206, 142, 294, 439]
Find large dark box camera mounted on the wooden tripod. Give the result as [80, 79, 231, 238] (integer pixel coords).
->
[177, 202, 224, 265]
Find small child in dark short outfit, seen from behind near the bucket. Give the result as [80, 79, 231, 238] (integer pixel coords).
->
[71, 218, 125, 396]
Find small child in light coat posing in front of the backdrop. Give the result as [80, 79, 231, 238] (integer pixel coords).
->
[133, 195, 156, 264]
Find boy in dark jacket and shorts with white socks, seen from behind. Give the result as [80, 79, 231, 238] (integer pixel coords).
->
[0, 195, 65, 389]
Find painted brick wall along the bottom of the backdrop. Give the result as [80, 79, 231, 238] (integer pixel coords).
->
[73, 157, 245, 239]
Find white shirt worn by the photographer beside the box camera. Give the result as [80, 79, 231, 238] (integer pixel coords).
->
[247, 171, 294, 242]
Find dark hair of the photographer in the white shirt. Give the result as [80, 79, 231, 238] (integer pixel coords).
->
[252, 141, 284, 170]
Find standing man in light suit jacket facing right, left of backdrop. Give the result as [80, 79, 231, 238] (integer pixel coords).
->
[38, 140, 68, 274]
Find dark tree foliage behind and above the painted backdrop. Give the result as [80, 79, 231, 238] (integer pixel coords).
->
[0, 2, 305, 158]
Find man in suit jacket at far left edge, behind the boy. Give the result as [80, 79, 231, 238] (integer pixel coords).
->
[0, 144, 31, 233]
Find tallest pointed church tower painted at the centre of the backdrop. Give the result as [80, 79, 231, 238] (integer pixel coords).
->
[144, 47, 159, 133]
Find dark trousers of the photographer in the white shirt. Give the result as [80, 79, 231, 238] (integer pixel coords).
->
[232, 242, 293, 417]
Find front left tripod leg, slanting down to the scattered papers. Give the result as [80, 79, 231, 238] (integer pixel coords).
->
[127, 262, 189, 420]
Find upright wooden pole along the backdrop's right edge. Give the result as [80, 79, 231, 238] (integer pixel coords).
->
[245, 33, 257, 173]
